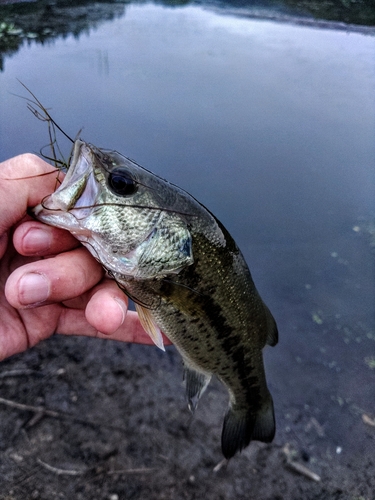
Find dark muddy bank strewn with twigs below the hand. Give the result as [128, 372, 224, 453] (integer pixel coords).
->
[0, 326, 375, 500]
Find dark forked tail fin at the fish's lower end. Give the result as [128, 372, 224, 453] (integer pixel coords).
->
[221, 395, 275, 459]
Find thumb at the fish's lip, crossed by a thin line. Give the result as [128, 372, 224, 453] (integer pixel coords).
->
[0, 154, 58, 235]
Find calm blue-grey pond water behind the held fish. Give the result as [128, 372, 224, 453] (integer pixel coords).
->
[0, 4, 375, 496]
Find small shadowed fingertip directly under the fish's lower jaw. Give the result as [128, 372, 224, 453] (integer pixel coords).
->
[13, 221, 80, 256]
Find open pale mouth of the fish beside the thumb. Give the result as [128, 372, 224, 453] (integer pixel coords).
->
[31, 140, 99, 231]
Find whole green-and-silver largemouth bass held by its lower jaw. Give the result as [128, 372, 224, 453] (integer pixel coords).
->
[34, 140, 278, 459]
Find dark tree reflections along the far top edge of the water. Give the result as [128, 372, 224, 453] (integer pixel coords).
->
[0, 0, 375, 71]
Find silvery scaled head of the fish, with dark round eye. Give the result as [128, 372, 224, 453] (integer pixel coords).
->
[33, 140, 193, 279]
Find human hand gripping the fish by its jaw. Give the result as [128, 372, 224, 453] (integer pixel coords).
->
[0, 154, 162, 360]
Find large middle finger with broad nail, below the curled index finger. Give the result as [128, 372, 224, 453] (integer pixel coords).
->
[5, 247, 104, 309]
